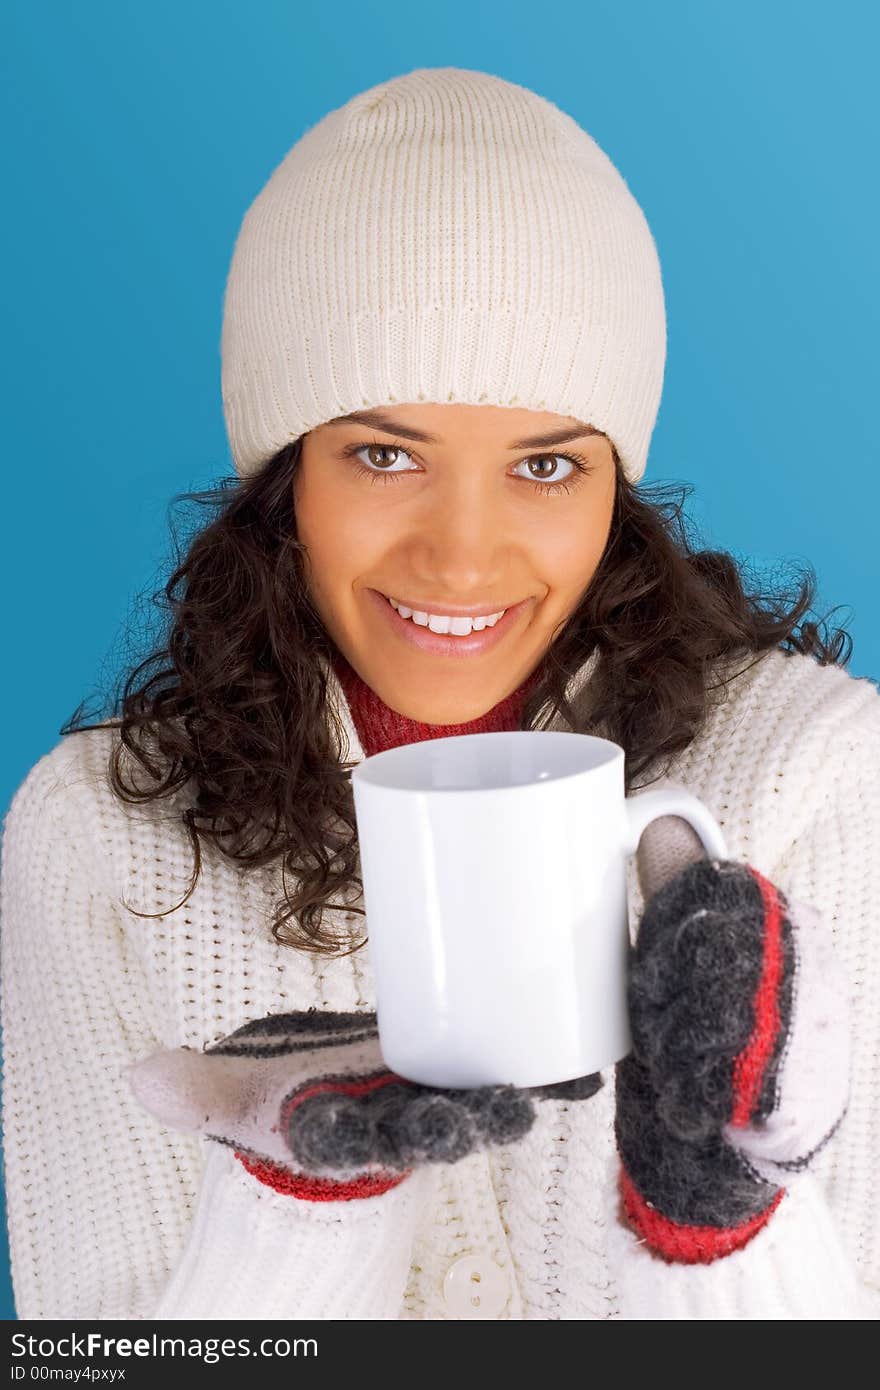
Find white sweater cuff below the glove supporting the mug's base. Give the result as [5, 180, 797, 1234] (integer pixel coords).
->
[152, 1141, 434, 1321]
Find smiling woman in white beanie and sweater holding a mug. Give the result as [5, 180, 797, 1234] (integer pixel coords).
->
[3, 68, 880, 1319]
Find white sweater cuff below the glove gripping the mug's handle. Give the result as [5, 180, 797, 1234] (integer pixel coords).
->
[609, 1173, 880, 1321]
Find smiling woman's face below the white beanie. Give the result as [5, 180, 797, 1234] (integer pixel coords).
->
[293, 403, 616, 724]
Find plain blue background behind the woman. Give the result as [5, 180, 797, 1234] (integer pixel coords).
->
[0, 0, 880, 1318]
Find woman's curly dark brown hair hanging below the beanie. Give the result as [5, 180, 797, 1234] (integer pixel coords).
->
[60, 436, 852, 955]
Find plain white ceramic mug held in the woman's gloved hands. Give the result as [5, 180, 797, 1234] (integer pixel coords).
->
[352, 730, 728, 1087]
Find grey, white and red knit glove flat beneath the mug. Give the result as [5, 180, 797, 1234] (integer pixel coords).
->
[127, 1009, 602, 1201]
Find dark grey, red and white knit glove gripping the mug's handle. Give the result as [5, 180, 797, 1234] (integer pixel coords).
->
[616, 817, 849, 1264]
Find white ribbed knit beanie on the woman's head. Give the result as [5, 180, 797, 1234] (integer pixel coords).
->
[221, 68, 666, 482]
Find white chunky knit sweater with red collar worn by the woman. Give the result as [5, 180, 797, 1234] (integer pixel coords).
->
[0, 652, 880, 1319]
